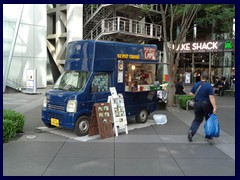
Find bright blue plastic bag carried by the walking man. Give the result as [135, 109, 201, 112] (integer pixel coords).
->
[204, 114, 220, 137]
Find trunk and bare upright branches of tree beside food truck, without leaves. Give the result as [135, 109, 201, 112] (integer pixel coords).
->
[160, 4, 201, 106]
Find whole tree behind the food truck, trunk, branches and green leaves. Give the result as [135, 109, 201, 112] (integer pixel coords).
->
[139, 4, 235, 106]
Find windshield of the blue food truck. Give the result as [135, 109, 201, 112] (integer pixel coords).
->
[53, 71, 90, 91]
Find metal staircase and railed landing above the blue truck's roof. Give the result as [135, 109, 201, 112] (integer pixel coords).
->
[83, 4, 162, 42]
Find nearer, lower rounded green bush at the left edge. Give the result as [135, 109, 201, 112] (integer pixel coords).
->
[3, 119, 16, 143]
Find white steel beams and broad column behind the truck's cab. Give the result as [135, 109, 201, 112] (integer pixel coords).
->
[47, 4, 83, 84]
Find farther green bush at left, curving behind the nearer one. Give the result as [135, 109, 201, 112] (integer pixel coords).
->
[3, 109, 25, 132]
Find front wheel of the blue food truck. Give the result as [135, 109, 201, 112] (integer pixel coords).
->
[74, 116, 90, 136]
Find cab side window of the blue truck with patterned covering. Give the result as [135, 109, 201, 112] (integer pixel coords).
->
[91, 74, 109, 92]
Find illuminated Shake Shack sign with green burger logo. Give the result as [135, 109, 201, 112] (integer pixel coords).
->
[173, 40, 234, 53]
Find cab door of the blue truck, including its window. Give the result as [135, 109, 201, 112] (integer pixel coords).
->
[90, 73, 111, 106]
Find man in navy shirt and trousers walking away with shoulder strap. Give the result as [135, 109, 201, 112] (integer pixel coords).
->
[188, 71, 217, 142]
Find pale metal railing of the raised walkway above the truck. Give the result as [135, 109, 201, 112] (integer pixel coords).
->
[84, 17, 162, 39]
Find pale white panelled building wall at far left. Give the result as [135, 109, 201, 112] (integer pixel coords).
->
[3, 4, 47, 88]
